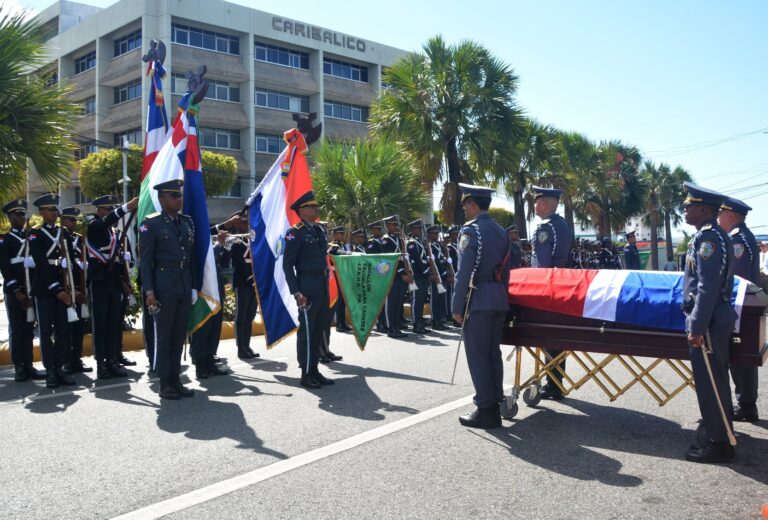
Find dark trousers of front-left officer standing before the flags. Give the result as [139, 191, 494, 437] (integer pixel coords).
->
[152, 292, 192, 379]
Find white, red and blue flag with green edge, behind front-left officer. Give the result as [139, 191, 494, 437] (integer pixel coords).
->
[138, 92, 221, 333]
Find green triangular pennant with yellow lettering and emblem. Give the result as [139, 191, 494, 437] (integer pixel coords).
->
[331, 253, 400, 350]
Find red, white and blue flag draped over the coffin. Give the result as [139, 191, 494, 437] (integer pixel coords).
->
[509, 268, 749, 331]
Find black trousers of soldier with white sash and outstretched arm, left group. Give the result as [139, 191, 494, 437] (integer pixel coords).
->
[90, 281, 123, 363]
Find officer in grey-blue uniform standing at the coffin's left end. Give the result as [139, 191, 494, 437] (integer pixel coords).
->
[452, 184, 511, 428]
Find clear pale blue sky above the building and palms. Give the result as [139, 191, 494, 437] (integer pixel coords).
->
[16, 0, 768, 233]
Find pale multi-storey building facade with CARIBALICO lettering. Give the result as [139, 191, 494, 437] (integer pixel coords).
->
[30, 0, 404, 220]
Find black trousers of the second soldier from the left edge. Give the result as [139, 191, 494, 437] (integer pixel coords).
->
[35, 295, 69, 370]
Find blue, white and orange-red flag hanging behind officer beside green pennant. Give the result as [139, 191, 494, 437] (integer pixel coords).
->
[246, 129, 338, 348]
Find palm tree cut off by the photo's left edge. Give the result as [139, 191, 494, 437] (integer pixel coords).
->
[0, 7, 77, 197]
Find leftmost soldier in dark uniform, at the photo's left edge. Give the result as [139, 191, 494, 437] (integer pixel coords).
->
[0, 199, 45, 383]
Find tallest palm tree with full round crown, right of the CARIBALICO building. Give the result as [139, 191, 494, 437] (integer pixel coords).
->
[370, 36, 523, 223]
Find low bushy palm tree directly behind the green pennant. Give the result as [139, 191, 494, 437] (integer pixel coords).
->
[310, 139, 431, 228]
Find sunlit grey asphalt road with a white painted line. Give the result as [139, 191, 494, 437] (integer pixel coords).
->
[0, 332, 768, 520]
